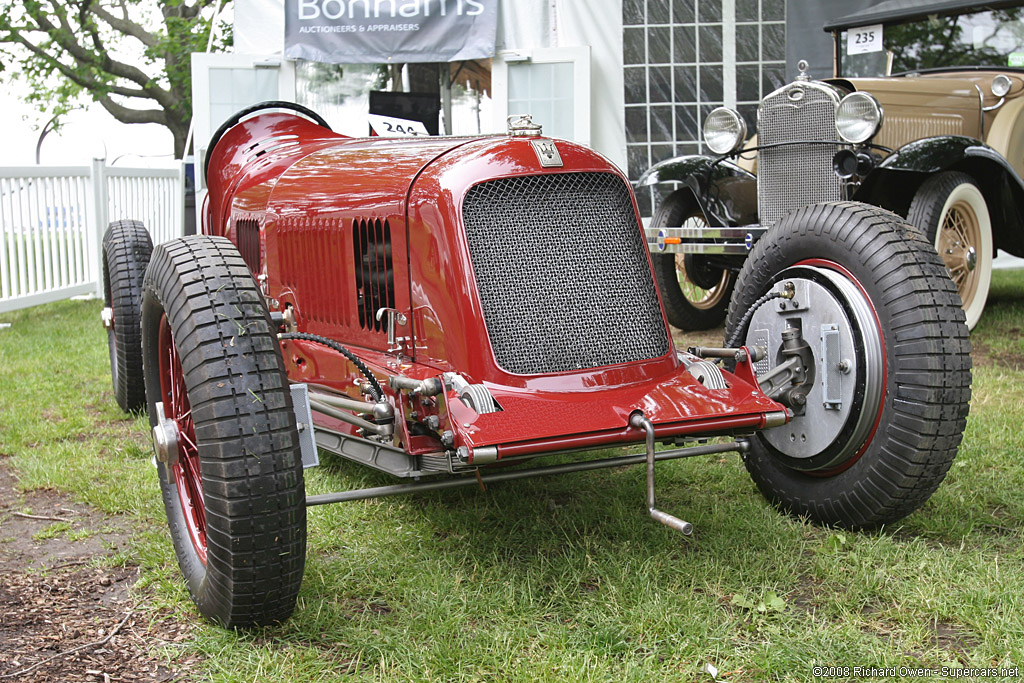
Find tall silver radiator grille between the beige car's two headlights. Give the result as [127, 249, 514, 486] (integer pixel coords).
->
[758, 88, 843, 225]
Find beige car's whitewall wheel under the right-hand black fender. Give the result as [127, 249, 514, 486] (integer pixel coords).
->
[906, 171, 995, 330]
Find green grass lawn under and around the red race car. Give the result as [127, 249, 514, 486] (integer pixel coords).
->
[0, 271, 1024, 682]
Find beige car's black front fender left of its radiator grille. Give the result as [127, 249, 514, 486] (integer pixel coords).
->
[636, 155, 758, 227]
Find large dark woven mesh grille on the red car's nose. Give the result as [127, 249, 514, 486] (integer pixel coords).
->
[463, 173, 669, 375]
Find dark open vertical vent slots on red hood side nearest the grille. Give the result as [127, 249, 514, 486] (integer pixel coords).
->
[352, 219, 394, 332]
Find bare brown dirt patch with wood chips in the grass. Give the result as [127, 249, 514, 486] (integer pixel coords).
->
[0, 454, 196, 683]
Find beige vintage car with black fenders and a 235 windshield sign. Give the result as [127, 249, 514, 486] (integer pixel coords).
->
[637, 0, 1024, 330]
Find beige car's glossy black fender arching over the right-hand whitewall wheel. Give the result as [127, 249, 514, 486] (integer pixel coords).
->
[852, 135, 1024, 256]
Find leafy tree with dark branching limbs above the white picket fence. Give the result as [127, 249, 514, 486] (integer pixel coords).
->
[0, 0, 231, 159]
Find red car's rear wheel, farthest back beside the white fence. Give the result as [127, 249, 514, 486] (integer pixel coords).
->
[102, 220, 153, 413]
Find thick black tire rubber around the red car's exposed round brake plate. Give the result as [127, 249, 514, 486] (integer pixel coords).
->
[726, 203, 971, 528]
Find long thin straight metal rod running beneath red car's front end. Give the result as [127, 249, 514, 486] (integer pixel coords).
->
[306, 438, 750, 507]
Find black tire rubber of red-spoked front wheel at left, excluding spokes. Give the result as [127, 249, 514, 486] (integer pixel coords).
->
[146, 236, 306, 627]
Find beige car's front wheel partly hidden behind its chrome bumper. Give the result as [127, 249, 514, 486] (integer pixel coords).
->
[650, 189, 736, 331]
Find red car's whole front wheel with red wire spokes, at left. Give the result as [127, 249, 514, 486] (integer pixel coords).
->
[142, 236, 306, 628]
